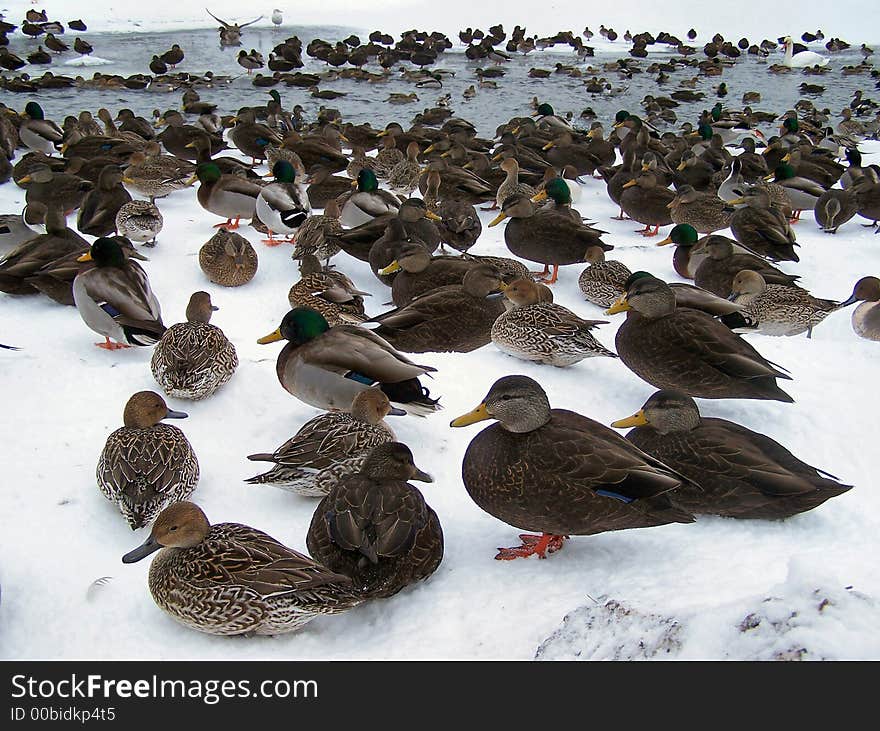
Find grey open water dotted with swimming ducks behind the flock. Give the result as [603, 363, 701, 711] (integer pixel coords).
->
[0, 26, 874, 136]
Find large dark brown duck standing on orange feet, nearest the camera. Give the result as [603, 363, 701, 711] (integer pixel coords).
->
[450, 375, 693, 560]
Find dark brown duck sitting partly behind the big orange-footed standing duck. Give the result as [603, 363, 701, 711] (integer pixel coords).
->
[611, 390, 851, 520]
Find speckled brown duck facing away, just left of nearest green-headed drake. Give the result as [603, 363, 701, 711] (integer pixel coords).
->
[150, 292, 238, 401]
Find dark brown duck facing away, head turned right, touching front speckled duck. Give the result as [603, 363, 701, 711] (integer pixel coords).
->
[306, 441, 443, 599]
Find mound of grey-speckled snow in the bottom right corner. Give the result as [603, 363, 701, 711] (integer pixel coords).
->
[535, 562, 880, 660]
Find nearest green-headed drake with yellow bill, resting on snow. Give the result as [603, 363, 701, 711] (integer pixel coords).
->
[257, 307, 441, 416]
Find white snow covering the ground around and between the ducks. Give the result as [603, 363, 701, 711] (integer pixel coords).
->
[0, 27, 880, 659]
